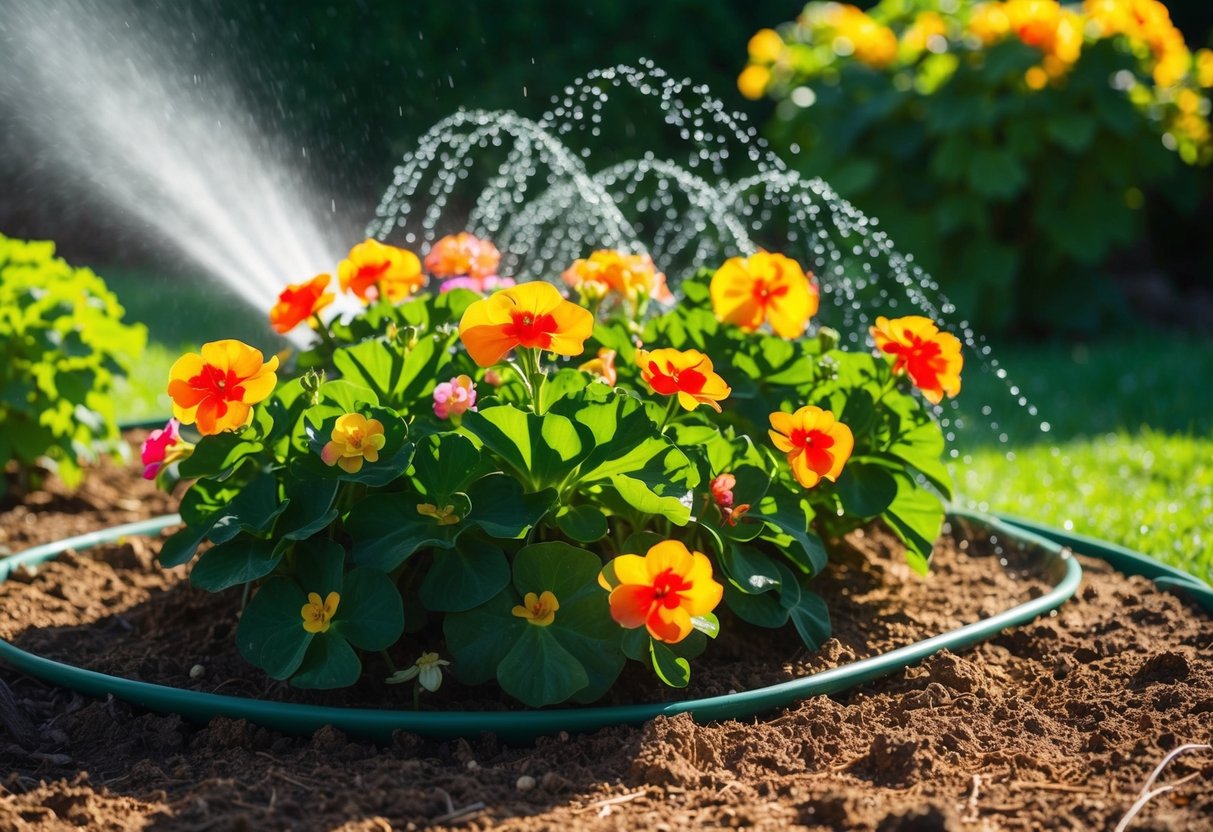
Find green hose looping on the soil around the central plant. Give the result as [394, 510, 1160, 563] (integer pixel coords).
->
[0, 512, 1081, 742]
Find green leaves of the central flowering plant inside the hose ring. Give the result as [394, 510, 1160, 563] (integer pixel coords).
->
[160, 251, 950, 707]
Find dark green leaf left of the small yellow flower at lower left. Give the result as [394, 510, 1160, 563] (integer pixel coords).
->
[235, 577, 313, 679]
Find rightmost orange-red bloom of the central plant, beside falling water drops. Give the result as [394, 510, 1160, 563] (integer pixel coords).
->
[871, 315, 964, 404]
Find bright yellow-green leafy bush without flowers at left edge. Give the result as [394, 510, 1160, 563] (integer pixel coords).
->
[0, 235, 147, 491]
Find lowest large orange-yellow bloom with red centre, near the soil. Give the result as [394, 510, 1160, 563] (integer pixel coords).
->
[598, 540, 724, 644]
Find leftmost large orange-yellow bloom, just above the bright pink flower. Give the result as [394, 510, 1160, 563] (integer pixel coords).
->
[169, 340, 278, 437]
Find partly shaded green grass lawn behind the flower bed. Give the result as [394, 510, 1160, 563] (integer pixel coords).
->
[102, 270, 1213, 582]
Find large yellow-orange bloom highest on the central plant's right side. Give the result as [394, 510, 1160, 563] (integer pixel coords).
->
[711, 251, 818, 338]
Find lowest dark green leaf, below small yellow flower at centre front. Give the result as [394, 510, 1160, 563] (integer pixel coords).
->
[497, 623, 590, 708]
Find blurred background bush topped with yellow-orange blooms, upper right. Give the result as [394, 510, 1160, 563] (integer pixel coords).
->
[739, 0, 1213, 331]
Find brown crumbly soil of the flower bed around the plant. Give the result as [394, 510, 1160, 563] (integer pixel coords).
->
[0, 456, 1213, 832]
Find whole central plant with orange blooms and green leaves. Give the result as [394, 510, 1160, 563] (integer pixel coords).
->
[160, 240, 962, 707]
